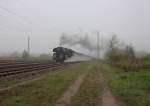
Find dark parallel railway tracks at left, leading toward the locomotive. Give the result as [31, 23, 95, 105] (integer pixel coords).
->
[0, 60, 70, 78]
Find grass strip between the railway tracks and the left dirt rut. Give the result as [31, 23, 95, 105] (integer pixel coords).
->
[0, 64, 86, 106]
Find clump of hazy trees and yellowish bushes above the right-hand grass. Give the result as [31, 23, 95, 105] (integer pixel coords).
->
[105, 36, 150, 71]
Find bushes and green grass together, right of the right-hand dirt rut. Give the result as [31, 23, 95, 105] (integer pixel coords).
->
[99, 36, 150, 106]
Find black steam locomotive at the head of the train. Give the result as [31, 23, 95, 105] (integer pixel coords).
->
[53, 47, 75, 62]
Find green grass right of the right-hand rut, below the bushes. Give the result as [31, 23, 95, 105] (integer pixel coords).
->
[99, 63, 150, 106]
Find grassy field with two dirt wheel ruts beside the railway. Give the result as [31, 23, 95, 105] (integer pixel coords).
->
[0, 61, 150, 106]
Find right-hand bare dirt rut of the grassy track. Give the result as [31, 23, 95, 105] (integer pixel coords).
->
[100, 74, 118, 106]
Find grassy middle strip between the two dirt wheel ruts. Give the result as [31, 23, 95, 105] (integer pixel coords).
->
[71, 64, 101, 106]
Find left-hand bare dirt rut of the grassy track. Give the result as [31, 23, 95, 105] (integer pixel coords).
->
[55, 73, 85, 106]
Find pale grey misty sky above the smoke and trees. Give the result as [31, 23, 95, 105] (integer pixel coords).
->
[0, 0, 150, 53]
